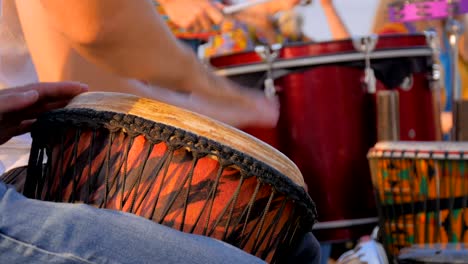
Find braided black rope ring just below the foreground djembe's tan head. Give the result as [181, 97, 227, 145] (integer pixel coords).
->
[27, 109, 317, 223]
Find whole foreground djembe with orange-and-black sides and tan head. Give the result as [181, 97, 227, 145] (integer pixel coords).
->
[24, 93, 316, 262]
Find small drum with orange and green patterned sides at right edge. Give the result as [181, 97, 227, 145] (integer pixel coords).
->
[368, 142, 468, 256]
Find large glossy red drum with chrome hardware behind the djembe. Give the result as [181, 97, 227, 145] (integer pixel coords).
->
[210, 35, 438, 241]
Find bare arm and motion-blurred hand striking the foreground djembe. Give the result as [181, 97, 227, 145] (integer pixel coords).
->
[17, 0, 279, 127]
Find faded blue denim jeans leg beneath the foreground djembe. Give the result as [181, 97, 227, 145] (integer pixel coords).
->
[0, 182, 264, 263]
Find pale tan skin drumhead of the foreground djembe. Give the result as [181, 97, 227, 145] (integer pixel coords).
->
[66, 92, 305, 188]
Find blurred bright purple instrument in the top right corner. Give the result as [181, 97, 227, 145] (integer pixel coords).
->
[388, 0, 468, 22]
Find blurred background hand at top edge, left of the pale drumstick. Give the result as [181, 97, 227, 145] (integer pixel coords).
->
[159, 0, 224, 32]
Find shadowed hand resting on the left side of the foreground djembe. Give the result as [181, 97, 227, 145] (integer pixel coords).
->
[0, 82, 88, 144]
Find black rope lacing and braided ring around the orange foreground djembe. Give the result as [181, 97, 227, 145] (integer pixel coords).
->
[25, 109, 316, 258]
